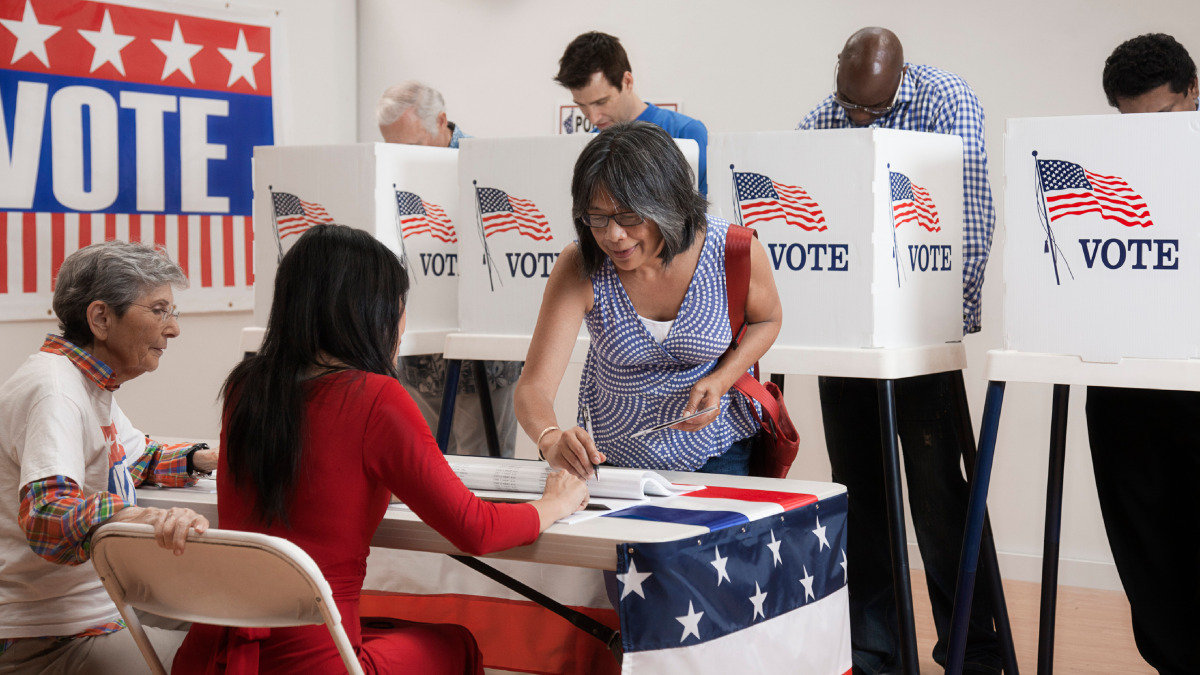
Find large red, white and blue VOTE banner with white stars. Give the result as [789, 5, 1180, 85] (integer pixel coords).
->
[0, 0, 278, 319]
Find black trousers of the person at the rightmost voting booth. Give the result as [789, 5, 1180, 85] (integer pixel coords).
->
[1087, 387, 1200, 675]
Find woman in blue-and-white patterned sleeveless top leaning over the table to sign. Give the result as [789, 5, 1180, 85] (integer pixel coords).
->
[516, 121, 782, 478]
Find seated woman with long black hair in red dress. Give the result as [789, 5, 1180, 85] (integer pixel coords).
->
[173, 226, 587, 675]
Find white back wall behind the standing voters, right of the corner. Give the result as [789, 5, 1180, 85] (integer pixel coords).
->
[358, 0, 1200, 589]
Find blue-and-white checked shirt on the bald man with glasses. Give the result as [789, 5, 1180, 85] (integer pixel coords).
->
[797, 64, 996, 333]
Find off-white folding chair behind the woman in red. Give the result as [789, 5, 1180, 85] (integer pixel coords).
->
[91, 522, 362, 675]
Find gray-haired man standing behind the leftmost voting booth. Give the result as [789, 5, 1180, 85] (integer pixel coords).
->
[376, 80, 522, 458]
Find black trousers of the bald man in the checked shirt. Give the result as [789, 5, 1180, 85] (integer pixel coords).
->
[820, 371, 1001, 674]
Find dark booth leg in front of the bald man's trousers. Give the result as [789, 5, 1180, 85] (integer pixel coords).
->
[877, 380, 920, 675]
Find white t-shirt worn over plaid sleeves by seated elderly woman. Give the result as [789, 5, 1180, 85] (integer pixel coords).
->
[0, 352, 145, 639]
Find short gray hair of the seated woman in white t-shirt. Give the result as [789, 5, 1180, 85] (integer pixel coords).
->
[53, 240, 187, 346]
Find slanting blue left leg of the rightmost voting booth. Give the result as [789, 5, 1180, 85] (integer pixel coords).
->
[946, 382, 1004, 675]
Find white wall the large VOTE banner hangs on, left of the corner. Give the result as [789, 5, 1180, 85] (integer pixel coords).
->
[0, 0, 356, 438]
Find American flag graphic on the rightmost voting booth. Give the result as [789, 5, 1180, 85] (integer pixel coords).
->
[1037, 160, 1154, 227]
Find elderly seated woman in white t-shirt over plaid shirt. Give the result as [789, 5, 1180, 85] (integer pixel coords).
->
[0, 241, 217, 674]
